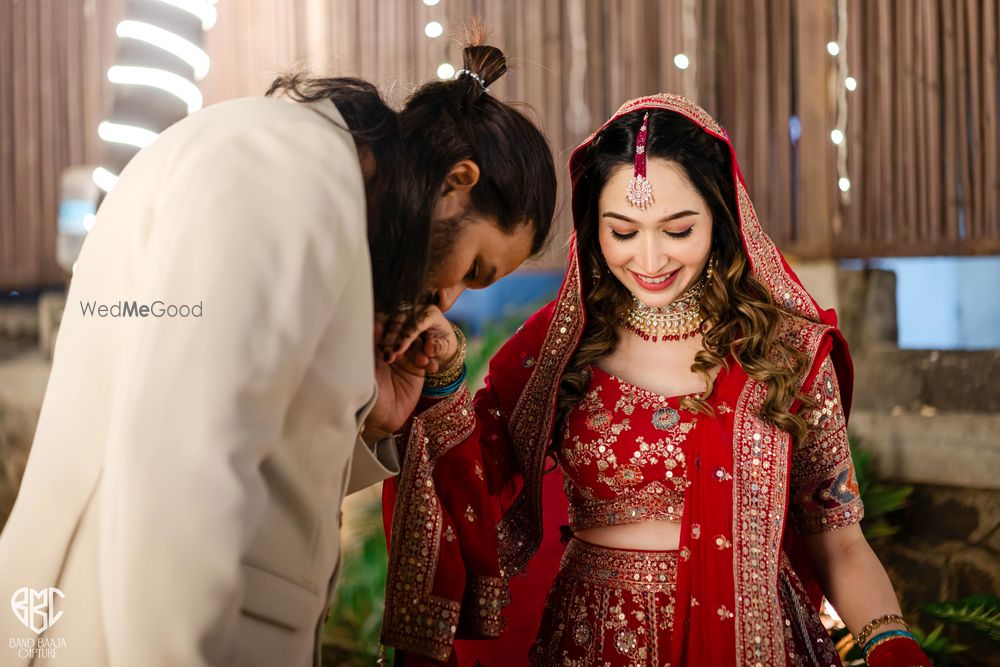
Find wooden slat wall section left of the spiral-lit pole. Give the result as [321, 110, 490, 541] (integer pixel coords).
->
[0, 0, 123, 290]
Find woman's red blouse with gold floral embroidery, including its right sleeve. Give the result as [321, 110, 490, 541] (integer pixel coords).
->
[557, 359, 862, 532]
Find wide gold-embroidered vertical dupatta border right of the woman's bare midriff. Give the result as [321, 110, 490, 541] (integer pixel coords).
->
[733, 317, 831, 667]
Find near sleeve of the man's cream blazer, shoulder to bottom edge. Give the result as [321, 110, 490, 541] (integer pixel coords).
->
[97, 112, 369, 667]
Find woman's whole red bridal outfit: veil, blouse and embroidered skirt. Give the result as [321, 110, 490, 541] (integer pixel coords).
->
[383, 95, 862, 667]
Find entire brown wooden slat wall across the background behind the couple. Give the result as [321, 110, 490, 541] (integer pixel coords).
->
[0, 0, 1000, 289]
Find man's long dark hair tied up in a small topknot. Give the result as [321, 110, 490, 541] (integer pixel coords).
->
[267, 31, 556, 314]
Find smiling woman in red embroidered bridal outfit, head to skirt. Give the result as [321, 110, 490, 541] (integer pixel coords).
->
[383, 95, 930, 667]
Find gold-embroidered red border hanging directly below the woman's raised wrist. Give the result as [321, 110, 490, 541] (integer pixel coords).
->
[382, 386, 478, 661]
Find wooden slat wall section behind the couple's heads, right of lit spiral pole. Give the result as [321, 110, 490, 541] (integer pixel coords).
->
[203, 0, 800, 265]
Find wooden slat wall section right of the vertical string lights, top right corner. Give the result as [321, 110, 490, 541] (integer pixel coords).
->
[833, 0, 1000, 257]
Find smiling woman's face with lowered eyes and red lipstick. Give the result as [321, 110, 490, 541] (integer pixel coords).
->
[597, 158, 712, 308]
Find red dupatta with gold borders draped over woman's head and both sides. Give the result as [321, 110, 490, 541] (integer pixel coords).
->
[383, 95, 853, 666]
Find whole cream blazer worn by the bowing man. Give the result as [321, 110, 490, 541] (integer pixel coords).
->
[0, 98, 398, 667]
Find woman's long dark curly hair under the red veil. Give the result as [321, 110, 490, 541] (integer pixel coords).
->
[556, 110, 815, 442]
